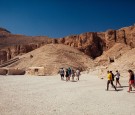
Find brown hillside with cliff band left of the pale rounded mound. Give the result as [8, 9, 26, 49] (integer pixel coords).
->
[0, 28, 54, 63]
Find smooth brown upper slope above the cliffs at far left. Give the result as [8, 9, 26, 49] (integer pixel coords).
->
[0, 28, 51, 49]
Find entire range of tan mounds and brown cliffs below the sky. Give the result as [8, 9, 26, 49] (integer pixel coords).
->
[0, 25, 135, 74]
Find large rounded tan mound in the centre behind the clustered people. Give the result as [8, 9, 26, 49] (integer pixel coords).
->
[8, 44, 94, 75]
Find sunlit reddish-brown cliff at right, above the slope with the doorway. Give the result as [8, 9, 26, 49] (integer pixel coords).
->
[105, 26, 135, 49]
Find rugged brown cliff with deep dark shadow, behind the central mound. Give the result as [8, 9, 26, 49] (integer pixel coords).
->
[56, 32, 105, 58]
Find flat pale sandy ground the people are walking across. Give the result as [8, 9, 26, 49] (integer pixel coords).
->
[0, 74, 135, 115]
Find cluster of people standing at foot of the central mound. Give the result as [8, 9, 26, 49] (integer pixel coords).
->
[59, 67, 80, 81]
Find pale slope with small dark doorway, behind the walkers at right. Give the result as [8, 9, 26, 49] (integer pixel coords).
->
[94, 43, 135, 77]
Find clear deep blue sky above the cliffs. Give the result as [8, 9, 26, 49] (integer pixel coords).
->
[0, 0, 135, 38]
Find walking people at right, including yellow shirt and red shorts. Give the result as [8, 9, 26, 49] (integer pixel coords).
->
[107, 70, 135, 92]
